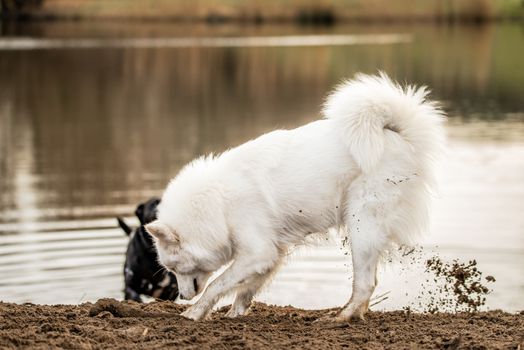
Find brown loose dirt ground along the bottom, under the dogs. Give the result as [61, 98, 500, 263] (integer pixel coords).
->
[0, 299, 524, 349]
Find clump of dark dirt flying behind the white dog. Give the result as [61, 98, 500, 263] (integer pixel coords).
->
[426, 256, 495, 313]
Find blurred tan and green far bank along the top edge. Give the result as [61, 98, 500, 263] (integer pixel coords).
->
[0, 0, 524, 23]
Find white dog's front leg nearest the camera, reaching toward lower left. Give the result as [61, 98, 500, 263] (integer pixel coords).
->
[181, 256, 275, 321]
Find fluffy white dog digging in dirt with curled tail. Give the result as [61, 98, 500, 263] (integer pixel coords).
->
[146, 74, 444, 320]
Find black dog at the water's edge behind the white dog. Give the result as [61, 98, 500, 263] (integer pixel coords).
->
[117, 198, 178, 302]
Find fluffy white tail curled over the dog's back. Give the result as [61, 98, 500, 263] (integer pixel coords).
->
[323, 73, 444, 173]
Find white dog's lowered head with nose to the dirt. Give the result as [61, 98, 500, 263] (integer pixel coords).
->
[145, 220, 215, 300]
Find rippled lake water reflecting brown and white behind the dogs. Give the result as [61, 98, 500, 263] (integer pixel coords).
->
[0, 22, 524, 311]
